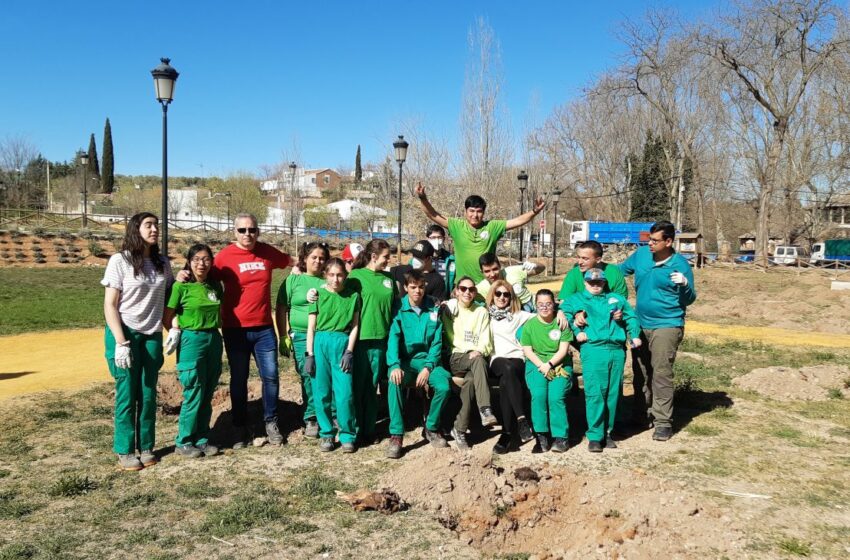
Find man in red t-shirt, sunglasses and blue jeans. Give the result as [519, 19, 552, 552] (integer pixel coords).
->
[213, 214, 292, 449]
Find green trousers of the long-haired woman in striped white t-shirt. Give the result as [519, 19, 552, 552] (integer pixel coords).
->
[104, 325, 163, 455]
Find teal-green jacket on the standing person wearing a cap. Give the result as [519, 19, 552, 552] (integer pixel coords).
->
[561, 290, 640, 345]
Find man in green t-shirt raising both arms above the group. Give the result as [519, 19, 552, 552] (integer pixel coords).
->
[416, 183, 545, 284]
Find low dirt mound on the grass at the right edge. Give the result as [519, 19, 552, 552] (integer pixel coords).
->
[732, 364, 850, 401]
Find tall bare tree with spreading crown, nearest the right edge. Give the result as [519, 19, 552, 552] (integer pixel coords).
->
[700, 0, 845, 264]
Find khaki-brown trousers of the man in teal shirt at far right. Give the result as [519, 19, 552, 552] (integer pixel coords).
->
[632, 327, 685, 428]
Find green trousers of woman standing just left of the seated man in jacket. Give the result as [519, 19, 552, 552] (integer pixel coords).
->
[354, 340, 387, 441]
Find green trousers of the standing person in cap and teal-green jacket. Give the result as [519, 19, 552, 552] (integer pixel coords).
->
[581, 343, 626, 442]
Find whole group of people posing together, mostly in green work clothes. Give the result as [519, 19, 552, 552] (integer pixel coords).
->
[102, 185, 696, 470]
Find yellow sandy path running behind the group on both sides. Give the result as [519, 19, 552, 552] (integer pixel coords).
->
[0, 280, 850, 400]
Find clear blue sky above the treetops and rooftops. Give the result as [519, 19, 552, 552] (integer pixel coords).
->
[0, 0, 711, 176]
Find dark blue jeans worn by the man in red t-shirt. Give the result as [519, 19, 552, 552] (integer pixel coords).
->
[222, 325, 280, 426]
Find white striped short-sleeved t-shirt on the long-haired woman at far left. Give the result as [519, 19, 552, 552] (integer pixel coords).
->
[100, 252, 174, 334]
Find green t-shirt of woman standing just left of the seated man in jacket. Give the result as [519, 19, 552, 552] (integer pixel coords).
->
[345, 267, 397, 340]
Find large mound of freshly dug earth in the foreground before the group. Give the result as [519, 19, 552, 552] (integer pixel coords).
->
[381, 450, 744, 559]
